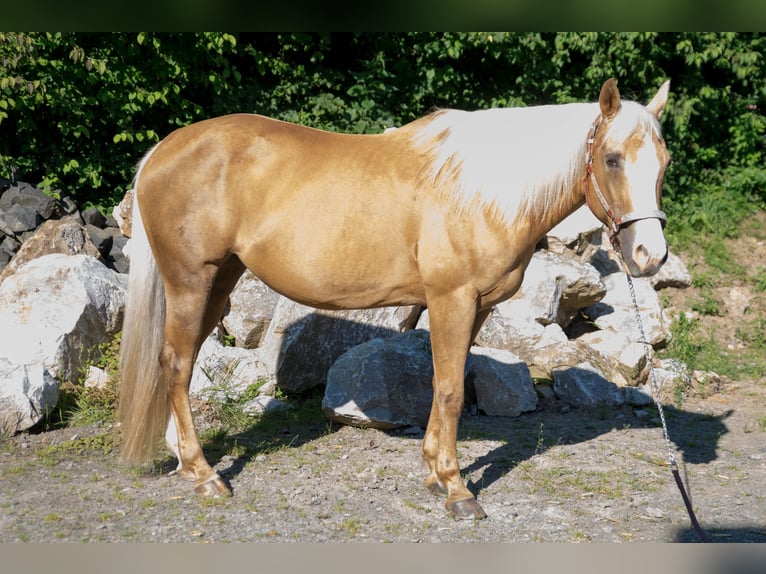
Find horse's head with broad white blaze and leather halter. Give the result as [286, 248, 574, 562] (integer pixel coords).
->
[585, 79, 670, 277]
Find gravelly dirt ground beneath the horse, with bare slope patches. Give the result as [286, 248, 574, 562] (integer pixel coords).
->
[0, 221, 766, 542]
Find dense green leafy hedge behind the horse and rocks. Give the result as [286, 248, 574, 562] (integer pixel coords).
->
[0, 32, 766, 218]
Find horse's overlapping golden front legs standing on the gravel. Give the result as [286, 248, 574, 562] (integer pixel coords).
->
[423, 290, 486, 519]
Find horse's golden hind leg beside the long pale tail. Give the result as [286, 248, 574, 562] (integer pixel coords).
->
[160, 257, 244, 496]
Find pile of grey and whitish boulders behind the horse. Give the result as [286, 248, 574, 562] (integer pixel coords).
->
[0, 184, 691, 436]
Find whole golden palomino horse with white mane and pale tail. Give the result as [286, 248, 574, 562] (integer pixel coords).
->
[119, 79, 669, 518]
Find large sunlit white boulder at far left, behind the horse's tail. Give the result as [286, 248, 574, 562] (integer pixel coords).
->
[0, 254, 127, 430]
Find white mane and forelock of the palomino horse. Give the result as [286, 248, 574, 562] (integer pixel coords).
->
[415, 102, 659, 222]
